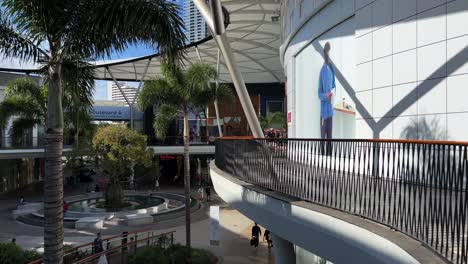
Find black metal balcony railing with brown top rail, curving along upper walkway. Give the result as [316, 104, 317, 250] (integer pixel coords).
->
[216, 139, 468, 263]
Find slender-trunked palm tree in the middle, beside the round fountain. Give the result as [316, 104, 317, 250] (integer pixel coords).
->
[138, 63, 217, 247]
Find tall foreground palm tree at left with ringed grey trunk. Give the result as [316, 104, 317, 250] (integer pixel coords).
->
[0, 0, 184, 263]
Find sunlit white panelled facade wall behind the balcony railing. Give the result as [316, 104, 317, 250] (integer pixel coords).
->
[280, 0, 468, 141]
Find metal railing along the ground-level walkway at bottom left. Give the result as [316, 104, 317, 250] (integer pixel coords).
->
[29, 229, 175, 264]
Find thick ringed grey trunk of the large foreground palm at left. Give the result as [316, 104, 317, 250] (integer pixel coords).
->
[44, 64, 63, 264]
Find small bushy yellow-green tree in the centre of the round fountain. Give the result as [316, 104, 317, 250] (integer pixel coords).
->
[93, 125, 153, 208]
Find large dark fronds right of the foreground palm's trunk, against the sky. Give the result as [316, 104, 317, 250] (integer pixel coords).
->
[64, 0, 185, 63]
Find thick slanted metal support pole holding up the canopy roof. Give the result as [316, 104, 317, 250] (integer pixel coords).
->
[192, 0, 264, 138]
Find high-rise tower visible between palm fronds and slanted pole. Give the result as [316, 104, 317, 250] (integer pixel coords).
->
[183, 0, 209, 43]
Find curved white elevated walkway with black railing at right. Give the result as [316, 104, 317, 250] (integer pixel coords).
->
[211, 138, 468, 263]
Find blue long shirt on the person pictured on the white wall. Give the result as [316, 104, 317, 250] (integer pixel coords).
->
[318, 63, 336, 119]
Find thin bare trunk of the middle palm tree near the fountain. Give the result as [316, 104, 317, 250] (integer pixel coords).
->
[184, 108, 190, 247]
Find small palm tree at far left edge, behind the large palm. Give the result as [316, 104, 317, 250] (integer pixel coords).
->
[0, 78, 47, 145]
